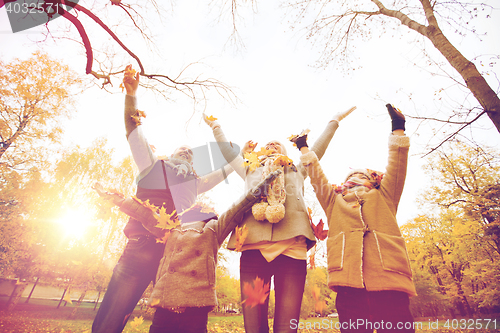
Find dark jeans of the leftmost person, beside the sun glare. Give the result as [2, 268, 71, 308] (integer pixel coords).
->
[92, 236, 165, 333]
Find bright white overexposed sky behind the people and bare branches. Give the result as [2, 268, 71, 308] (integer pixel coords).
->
[0, 1, 500, 272]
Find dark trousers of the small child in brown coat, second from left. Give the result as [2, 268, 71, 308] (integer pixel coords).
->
[149, 306, 212, 333]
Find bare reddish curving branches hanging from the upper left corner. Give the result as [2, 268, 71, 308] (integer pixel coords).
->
[0, 0, 235, 100]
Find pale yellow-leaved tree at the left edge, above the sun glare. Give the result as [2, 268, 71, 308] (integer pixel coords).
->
[0, 52, 81, 172]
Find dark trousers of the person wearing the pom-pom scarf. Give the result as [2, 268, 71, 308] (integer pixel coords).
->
[240, 250, 307, 333]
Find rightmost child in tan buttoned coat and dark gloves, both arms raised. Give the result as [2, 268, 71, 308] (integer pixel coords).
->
[293, 104, 416, 333]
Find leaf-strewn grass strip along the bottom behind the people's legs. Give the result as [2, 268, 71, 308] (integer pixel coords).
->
[0, 297, 500, 333]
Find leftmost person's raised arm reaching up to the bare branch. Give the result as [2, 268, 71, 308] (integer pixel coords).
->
[123, 65, 156, 172]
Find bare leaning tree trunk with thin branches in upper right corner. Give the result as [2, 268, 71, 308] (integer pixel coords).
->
[222, 0, 500, 148]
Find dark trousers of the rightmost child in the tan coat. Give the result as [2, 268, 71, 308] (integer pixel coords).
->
[336, 287, 415, 333]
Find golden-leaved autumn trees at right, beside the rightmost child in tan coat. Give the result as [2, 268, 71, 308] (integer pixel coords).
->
[402, 142, 500, 316]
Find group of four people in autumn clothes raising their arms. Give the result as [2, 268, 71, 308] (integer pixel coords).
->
[92, 65, 416, 333]
